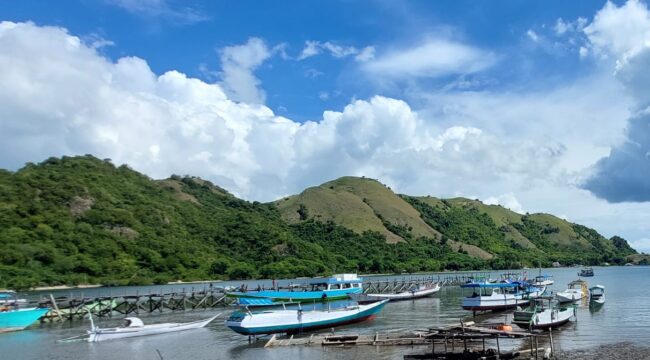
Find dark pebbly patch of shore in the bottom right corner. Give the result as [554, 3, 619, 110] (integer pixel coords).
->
[556, 343, 650, 360]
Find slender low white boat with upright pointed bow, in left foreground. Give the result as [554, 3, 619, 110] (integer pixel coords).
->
[87, 314, 221, 342]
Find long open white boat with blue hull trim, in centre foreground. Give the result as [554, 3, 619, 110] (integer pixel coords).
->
[226, 300, 388, 335]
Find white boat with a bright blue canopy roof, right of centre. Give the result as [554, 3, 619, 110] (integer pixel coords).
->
[461, 282, 546, 311]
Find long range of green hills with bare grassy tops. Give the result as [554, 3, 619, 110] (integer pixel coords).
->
[0, 155, 636, 288]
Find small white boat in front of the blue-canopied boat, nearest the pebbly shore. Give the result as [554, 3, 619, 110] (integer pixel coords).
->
[512, 297, 575, 329]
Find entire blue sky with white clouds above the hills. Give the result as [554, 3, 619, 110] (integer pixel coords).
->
[0, 0, 650, 251]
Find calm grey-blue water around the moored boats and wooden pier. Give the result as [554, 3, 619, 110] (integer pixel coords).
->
[0, 266, 650, 360]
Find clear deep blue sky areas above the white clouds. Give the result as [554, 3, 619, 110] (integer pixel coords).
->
[2, 0, 624, 121]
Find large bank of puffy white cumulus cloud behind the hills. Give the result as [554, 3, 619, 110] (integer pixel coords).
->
[0, 22, 558, 200]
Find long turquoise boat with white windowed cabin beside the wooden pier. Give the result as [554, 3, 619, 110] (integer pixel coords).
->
[226, 274, 363, 302]
